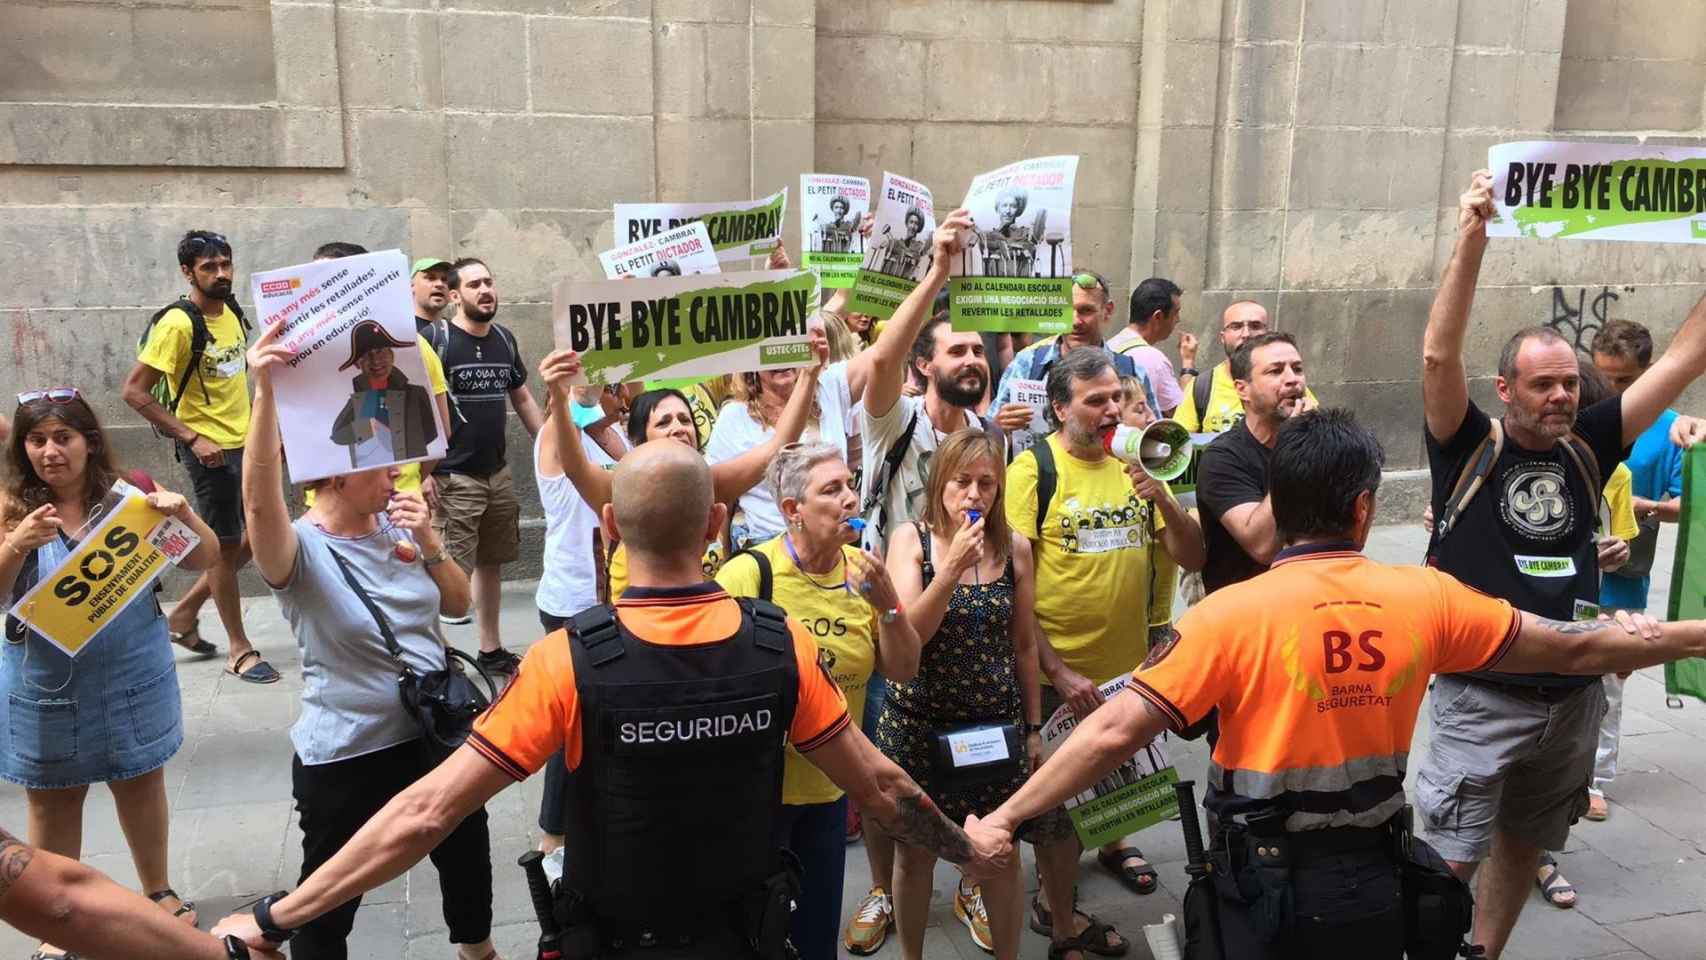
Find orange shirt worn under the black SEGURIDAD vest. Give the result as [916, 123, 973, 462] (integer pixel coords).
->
[467, 583, 850, 781]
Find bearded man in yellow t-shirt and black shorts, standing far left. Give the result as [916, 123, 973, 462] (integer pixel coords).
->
[123, 230, 278, 684]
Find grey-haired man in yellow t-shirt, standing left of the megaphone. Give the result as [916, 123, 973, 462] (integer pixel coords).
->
[1005, 350, 1203, 957]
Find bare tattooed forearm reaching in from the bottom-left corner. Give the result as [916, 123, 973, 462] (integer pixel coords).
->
[0, 829, 278, 960]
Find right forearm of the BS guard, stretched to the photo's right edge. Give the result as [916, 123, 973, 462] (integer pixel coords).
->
[1491, 612, 1706, 675]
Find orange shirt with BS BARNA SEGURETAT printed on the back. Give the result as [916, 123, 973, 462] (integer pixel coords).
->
[1133, 542, 1522, 830]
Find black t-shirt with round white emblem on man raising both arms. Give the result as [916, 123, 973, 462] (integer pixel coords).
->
[1425, 397, 1629, 685]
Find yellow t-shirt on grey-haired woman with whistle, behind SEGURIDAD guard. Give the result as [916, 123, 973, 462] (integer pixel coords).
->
[717, 537, 873, 805]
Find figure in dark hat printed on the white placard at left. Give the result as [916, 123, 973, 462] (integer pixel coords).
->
[331, 321, 438, 469]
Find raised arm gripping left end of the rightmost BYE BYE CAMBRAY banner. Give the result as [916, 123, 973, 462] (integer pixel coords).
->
[1421, 171, 1487, 443]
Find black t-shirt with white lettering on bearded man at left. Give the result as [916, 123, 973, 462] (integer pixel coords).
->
[433, 322, 527, 477]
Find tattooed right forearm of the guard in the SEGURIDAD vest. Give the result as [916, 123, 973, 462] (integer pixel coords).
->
[805, 726, 1013, 876]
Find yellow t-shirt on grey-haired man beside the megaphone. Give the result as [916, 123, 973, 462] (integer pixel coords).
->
[1007, 433, 1167, 684]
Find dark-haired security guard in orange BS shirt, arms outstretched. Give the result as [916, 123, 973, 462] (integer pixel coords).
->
[967, 409, 1706, 960]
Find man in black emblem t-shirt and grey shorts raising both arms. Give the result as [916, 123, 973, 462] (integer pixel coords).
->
[1416, 171, 1706, 958]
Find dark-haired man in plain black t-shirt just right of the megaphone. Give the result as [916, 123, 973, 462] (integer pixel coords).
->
[1196, 333, 1315, 593]
